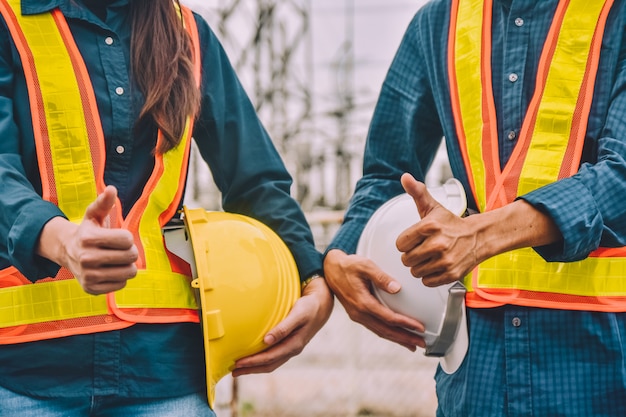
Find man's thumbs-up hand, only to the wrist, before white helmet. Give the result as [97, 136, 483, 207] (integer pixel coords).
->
[396, 174, 478, 287]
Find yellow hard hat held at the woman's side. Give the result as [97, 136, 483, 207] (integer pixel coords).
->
[161, 207, 300, 407]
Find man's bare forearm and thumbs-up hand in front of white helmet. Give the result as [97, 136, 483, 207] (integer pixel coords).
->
[396, 174, 563, 287]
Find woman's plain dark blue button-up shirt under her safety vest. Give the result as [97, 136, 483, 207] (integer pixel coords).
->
[0, 0, 321, 396]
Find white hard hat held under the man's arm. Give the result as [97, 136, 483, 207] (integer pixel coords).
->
[356, 179, 468, 373]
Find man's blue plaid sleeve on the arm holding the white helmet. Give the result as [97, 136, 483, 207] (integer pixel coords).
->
[327, 13, 443, 253]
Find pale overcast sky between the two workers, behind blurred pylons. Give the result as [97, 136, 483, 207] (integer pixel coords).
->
[182, 0, 445, 205]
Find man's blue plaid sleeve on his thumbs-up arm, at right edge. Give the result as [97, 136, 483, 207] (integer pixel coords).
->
[521, 24, 626, 262]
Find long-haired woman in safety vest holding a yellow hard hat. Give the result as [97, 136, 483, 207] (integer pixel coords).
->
[0, 0, 332, 417]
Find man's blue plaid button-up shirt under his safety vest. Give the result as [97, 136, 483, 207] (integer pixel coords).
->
[328, 0, 626, 417]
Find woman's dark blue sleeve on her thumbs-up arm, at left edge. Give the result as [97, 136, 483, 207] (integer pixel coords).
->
[0, 21, 63, 281]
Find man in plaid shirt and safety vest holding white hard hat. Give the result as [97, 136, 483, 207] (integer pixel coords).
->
[324, 0, 626, 416]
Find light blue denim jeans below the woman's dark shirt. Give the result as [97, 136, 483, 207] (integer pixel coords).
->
[0, 387, 215, 417]
